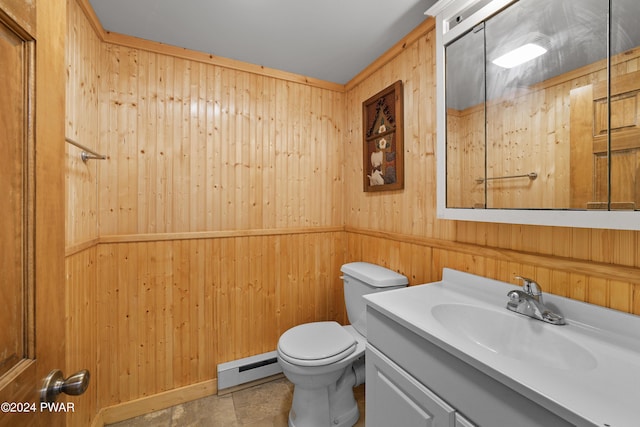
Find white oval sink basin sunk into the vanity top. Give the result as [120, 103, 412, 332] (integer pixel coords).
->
[431, 304, 598, 370]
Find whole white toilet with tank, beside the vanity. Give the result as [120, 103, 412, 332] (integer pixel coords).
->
[278, 262, 409, 427]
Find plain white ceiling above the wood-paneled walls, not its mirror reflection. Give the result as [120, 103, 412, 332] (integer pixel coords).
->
[89, 0, 435, 84]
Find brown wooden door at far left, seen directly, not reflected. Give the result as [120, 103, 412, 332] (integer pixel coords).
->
[0, 0, 66, 426]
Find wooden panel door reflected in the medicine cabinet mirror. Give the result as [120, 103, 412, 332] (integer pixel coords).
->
[570, 71, 640, 210]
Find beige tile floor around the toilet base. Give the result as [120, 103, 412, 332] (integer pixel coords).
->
[108, 378, 365, 427]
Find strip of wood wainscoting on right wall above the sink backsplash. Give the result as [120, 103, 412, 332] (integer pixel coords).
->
[345, 227, 640, 314]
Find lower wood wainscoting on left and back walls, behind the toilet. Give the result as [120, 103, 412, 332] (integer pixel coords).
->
[67, 227, 346, 426]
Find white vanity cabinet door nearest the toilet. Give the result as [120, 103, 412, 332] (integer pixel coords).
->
[366, 346, 455, 427]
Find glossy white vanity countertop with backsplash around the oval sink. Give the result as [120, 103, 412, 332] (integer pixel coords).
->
[365, 269, 640, 427]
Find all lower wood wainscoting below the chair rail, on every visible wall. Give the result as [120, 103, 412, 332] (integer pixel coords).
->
[67, 227, 640, 426]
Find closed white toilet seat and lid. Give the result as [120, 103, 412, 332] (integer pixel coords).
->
[278, 322, 357, 366]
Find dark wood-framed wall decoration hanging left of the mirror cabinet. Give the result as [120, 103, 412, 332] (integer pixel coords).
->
[362, 80, 404, 191]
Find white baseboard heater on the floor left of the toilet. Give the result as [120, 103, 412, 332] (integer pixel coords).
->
[218, 351, 282, 390]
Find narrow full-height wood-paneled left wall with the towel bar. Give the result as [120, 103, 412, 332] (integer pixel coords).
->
[64, 0, 103, 427]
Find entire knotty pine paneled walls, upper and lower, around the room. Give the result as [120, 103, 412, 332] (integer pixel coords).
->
[66, 0, 640, 425]
